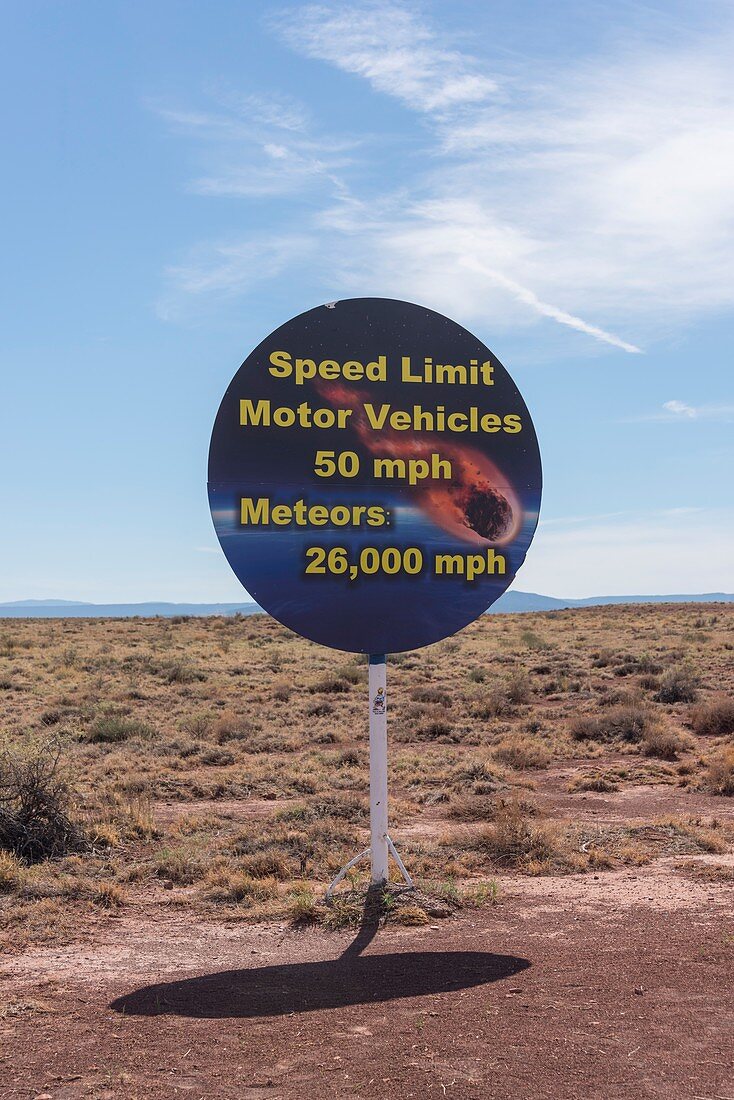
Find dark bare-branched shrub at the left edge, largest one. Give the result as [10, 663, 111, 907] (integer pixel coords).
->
[0, 744, 84, 862]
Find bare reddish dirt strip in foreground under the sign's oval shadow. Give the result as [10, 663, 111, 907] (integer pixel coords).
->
[0, 857, 734, 1100]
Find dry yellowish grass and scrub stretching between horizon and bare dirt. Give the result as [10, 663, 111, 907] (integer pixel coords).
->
[0, 605, 734, 947]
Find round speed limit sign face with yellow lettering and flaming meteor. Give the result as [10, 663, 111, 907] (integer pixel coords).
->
[209, 298, 541, 653]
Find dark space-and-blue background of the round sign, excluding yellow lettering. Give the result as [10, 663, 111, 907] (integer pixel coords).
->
[209, 299, 541, 652]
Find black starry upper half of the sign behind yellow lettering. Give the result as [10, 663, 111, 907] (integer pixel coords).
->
[209, 298, 539, 487]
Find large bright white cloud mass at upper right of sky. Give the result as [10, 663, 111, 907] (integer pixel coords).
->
[268, 3, 734, 350]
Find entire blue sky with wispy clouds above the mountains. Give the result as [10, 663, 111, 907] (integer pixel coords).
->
[0, 0, 734, 601]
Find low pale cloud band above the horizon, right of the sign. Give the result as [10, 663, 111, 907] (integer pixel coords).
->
[517, 508, 734, 598]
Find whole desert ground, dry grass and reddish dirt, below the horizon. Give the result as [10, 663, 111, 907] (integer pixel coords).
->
[0, 604, 734, 1100]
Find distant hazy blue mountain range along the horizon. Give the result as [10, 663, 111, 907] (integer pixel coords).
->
[0, 592, 734, 618]
